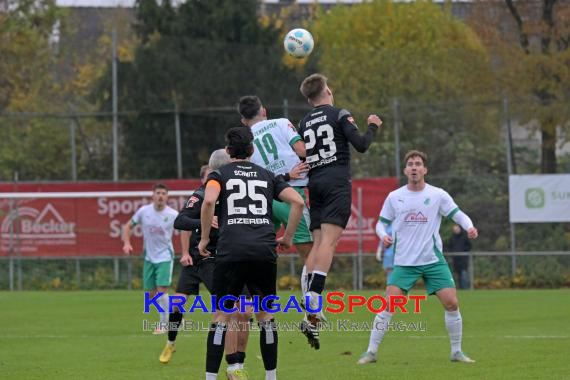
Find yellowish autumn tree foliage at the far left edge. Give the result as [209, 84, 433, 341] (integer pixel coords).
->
[0, 0, 69, 180]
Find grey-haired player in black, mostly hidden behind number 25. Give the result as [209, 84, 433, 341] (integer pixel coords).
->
[159, 149, 249, 377]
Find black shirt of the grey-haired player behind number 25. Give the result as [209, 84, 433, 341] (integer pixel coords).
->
[174, 185, 220, 265]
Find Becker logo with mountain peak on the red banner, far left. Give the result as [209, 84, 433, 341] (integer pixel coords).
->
[1, 203, 76, 242]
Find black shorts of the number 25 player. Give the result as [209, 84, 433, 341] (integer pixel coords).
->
[213, 261, 277, 309]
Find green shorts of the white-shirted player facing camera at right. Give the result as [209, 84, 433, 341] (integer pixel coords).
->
[388, 262, 455, 296]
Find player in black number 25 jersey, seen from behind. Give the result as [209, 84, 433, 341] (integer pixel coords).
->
[198, 127, 304, 380]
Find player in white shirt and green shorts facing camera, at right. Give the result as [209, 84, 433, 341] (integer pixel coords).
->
[358, 150, 478, 364]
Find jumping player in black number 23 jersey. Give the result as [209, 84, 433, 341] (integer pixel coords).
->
[299, 74, 382, 326]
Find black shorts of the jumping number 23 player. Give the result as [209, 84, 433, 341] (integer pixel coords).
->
[309, 180, 352, 231]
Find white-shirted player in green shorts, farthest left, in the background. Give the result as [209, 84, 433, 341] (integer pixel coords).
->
[122, 183, 178, 334]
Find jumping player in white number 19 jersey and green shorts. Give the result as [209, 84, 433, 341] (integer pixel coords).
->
[238, 95, 320, 349]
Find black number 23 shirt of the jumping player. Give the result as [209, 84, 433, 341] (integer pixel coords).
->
[299, 105, 378, 178]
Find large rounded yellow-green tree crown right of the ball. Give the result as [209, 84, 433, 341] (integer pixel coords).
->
[312, 1, 498, 175]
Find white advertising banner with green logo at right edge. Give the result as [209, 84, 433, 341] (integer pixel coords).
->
[509, 174, 570, 223]
